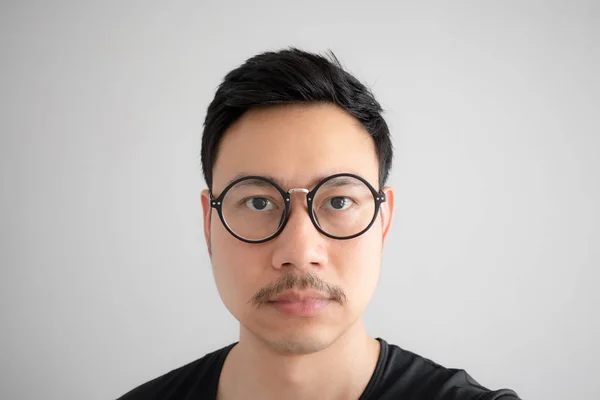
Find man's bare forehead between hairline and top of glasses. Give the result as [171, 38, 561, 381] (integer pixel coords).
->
[213, 104, 378, 192]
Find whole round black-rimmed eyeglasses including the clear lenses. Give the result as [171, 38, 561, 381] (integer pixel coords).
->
[210, 173, 386, 243]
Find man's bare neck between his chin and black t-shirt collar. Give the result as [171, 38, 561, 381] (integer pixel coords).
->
[218, 319, 379, 400]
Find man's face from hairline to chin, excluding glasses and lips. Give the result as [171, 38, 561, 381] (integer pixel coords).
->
[202, 104, 394, 354]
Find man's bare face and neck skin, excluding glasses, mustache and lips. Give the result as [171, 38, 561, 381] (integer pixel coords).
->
[201, 104, 394, 400]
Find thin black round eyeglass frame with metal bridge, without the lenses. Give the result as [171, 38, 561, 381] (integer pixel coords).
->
[210, 173, 386, 244]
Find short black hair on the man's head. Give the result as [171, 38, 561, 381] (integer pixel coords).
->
[201, 48, 393, 190]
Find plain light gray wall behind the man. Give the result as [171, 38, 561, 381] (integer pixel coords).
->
[0, 0, 600, 400]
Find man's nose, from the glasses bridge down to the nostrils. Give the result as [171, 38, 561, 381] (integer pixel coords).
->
[272, 191, 327, 272]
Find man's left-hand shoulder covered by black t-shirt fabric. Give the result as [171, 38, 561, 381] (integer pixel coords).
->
[118, 344, 235, 400]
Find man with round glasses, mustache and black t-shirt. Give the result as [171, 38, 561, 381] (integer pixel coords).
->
[121, 49, 517, 400]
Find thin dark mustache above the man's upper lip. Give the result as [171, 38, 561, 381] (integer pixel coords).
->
[248, 272, 347, 307]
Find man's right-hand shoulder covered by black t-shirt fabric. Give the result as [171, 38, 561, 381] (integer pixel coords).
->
[365, 339, 518, 400]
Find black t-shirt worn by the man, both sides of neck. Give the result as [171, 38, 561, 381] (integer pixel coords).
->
[118, 338, 518, 400]
